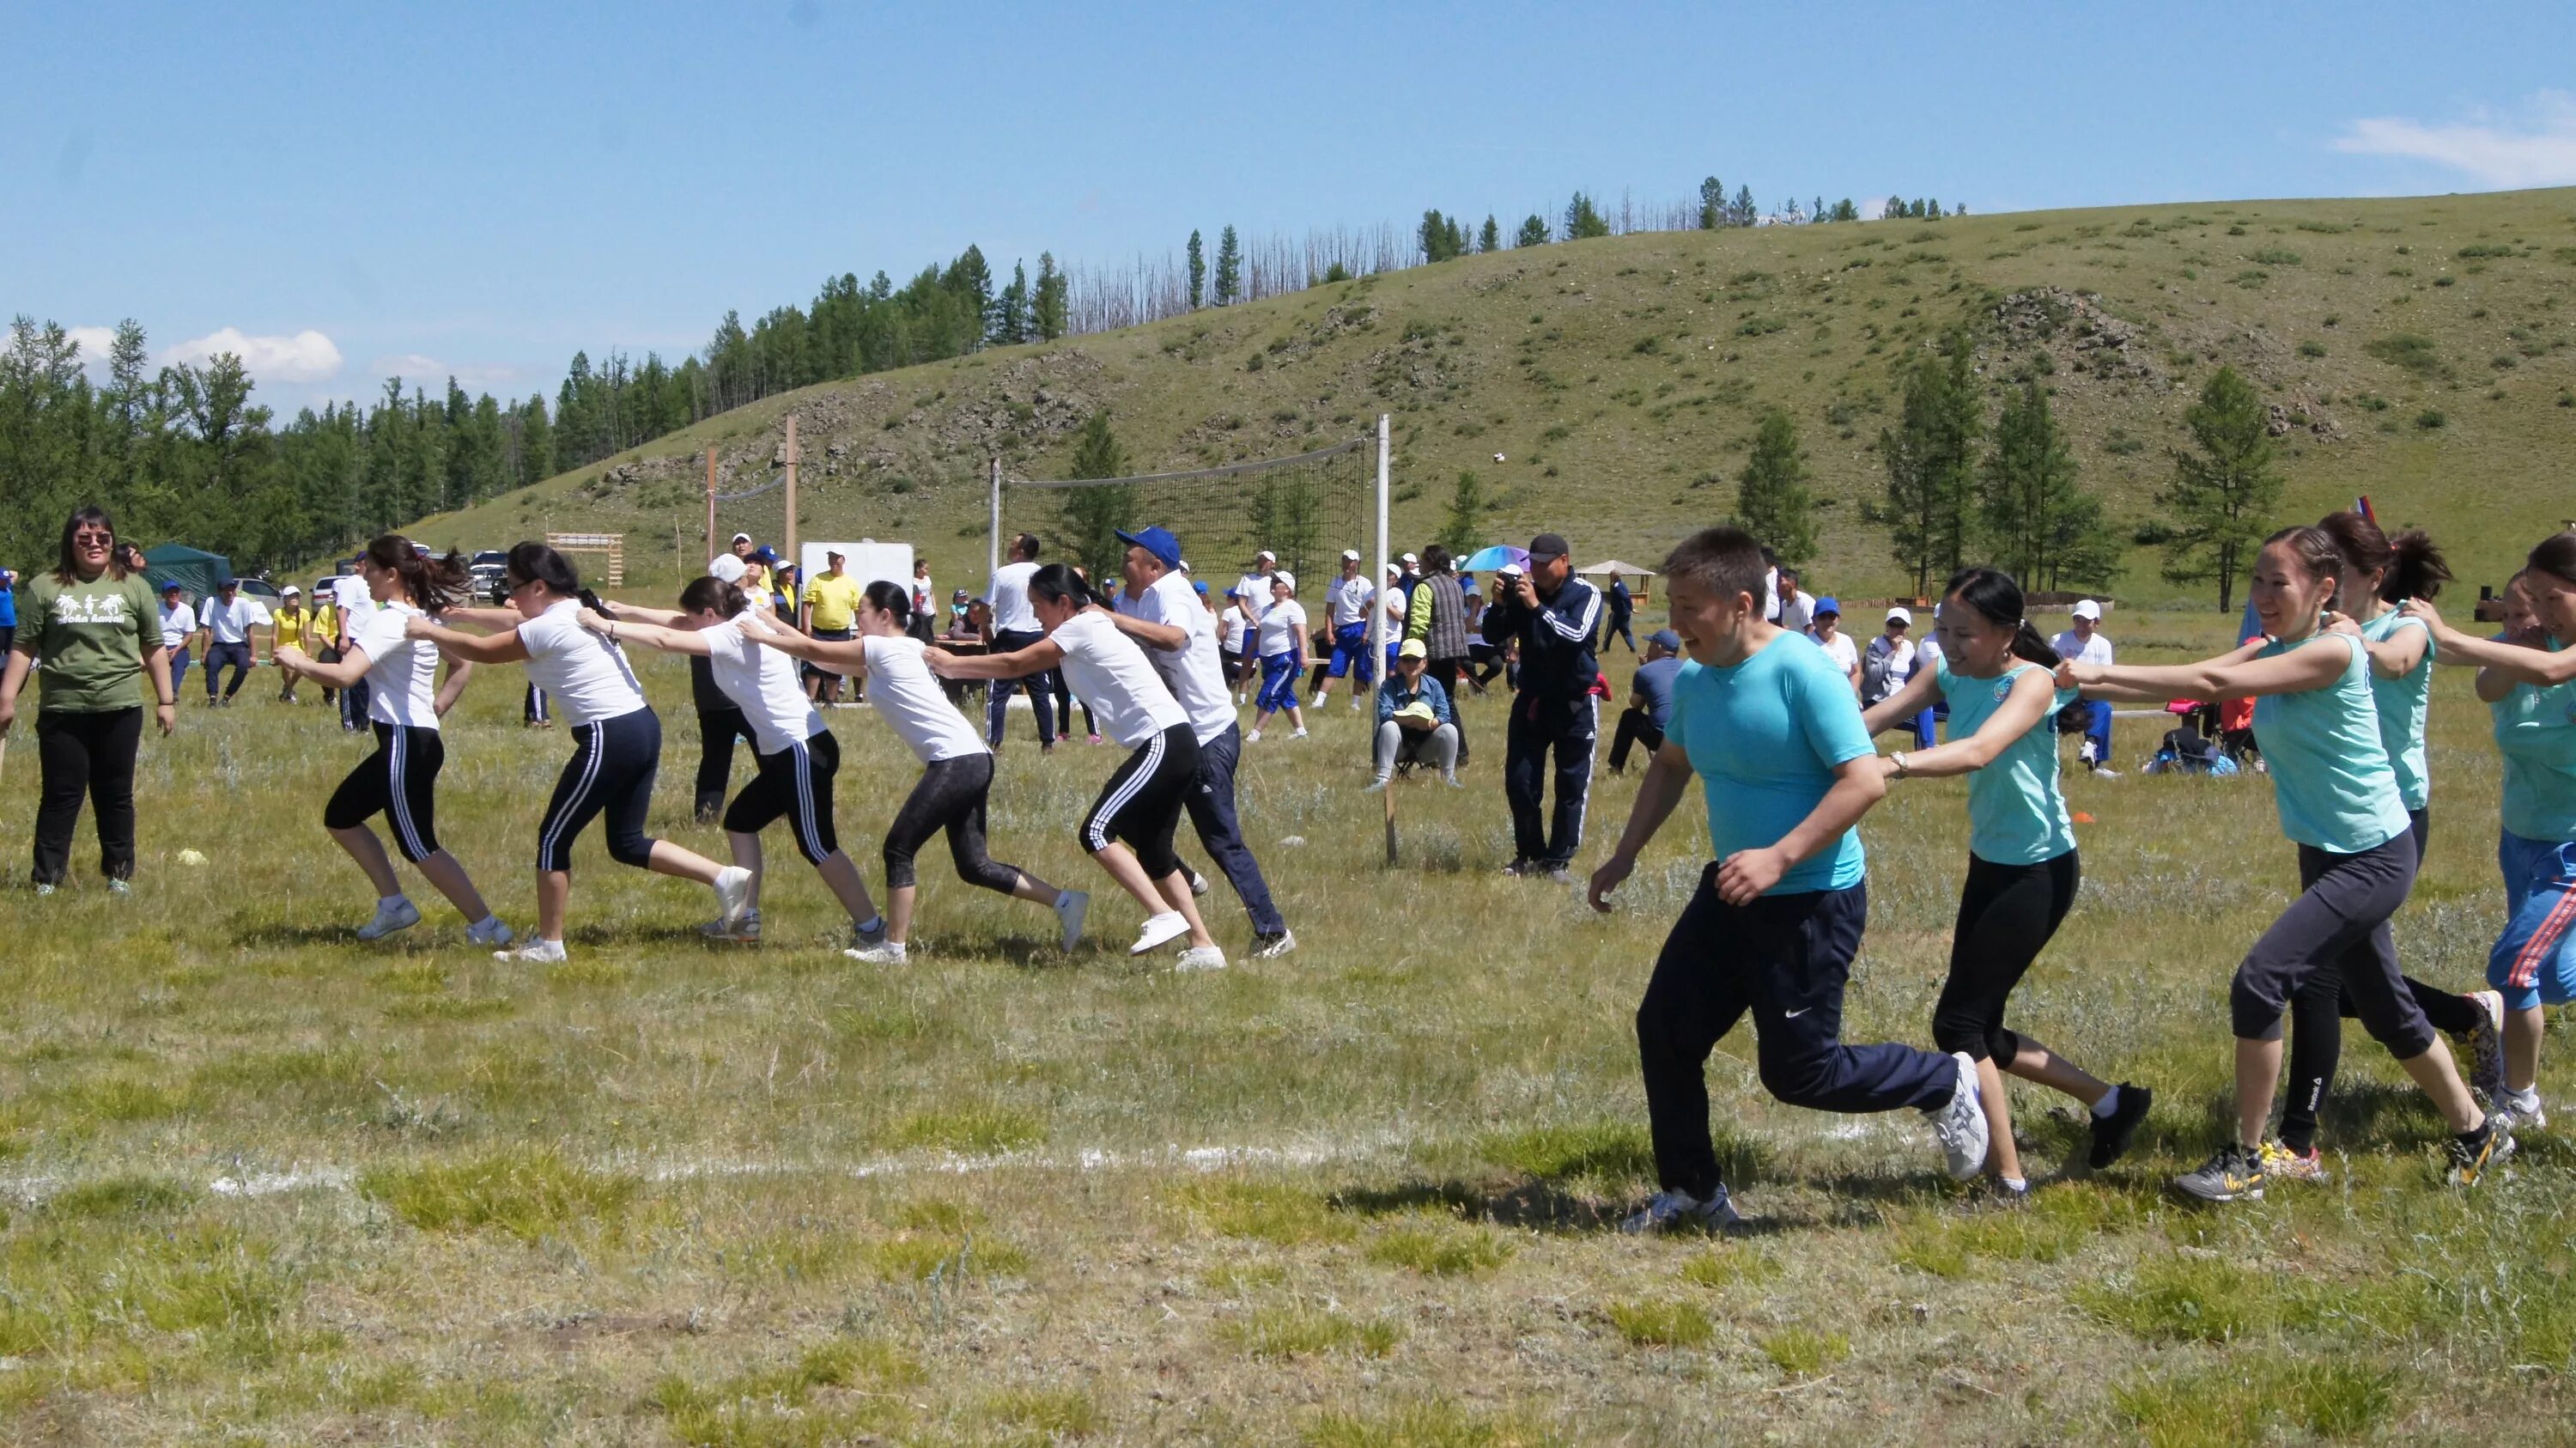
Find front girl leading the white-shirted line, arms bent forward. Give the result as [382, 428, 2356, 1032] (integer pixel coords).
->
[273, 533, 510, 946]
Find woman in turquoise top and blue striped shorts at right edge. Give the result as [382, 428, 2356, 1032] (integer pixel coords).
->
[2406, 533, 2576, 1126]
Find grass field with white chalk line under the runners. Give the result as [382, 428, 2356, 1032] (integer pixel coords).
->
[0, 603, 2576, 1445]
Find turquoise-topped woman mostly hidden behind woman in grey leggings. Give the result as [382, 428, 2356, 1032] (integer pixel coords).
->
[2264, 513, 2504, 1180]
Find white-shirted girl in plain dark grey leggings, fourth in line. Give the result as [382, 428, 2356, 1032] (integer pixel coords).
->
[744, 580, 1092, 966]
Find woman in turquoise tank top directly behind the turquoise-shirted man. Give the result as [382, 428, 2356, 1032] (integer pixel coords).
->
[1862, 567, 2154, 1196]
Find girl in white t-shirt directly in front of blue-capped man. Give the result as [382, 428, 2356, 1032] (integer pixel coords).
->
[922, 564, 1226, 971]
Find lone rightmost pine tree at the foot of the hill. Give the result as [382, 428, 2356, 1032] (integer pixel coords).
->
[2156, 366, 2282, 613]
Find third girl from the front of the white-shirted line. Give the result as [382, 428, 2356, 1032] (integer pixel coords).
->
[590, 577, 886, 948]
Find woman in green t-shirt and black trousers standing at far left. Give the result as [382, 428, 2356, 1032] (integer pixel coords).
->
[0, 508, 178, 894]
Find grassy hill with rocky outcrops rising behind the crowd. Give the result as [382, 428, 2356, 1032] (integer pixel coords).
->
[397, 191, 2576, 603]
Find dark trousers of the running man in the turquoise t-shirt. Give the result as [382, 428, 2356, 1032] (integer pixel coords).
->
[1636, 863, 1958, 1201]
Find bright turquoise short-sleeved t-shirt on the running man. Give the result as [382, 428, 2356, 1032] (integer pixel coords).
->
[1664, 634, 1878, 894]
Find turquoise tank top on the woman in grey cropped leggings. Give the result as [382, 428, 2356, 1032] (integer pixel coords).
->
[2254, 634, 2409, 855]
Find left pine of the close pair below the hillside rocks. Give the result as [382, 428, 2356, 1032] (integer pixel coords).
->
[1878, 330, 1986, 595]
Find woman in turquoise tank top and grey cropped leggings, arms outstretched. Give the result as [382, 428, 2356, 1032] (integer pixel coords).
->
[2058, 528, 2514, 1201]
